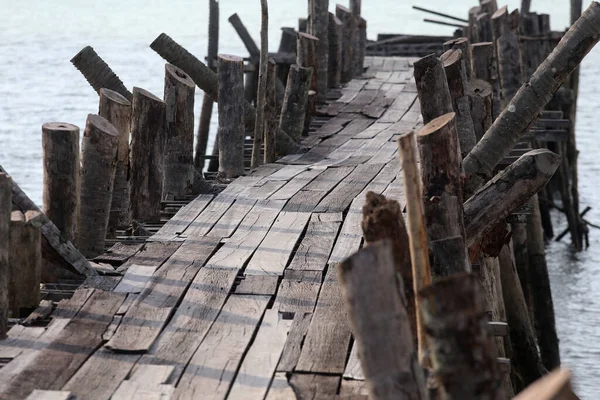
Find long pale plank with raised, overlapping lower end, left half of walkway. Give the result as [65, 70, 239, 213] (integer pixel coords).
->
[106, 238, 219, 353]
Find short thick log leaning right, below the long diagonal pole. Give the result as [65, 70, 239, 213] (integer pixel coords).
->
[464, 149, 560, 247]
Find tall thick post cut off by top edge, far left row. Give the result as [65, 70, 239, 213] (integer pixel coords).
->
[308, 0, 330, 103]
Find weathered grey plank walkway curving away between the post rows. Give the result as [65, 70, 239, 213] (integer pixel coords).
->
[0, 57, 421, 400]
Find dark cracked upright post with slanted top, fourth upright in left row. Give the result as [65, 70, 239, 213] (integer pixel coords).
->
[129, 88, 166, 222]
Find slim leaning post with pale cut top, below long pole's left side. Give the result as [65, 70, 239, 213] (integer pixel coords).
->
[440, 49, 477, 157]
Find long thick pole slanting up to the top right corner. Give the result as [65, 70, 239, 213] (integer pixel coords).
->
[463, 2, 600, 191]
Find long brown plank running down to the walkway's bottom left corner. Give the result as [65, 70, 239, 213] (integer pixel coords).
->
[6, 291, 125, 399]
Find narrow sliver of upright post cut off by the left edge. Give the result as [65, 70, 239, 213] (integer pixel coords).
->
[0, 173, 12, 340]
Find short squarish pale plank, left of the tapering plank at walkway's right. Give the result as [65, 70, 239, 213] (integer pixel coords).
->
[273, 270, 323, 313]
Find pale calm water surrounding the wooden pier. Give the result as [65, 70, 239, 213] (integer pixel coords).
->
[0, 0, 600, 400]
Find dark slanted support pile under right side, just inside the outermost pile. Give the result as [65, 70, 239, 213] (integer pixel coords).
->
[498, 246, 546, 386]
